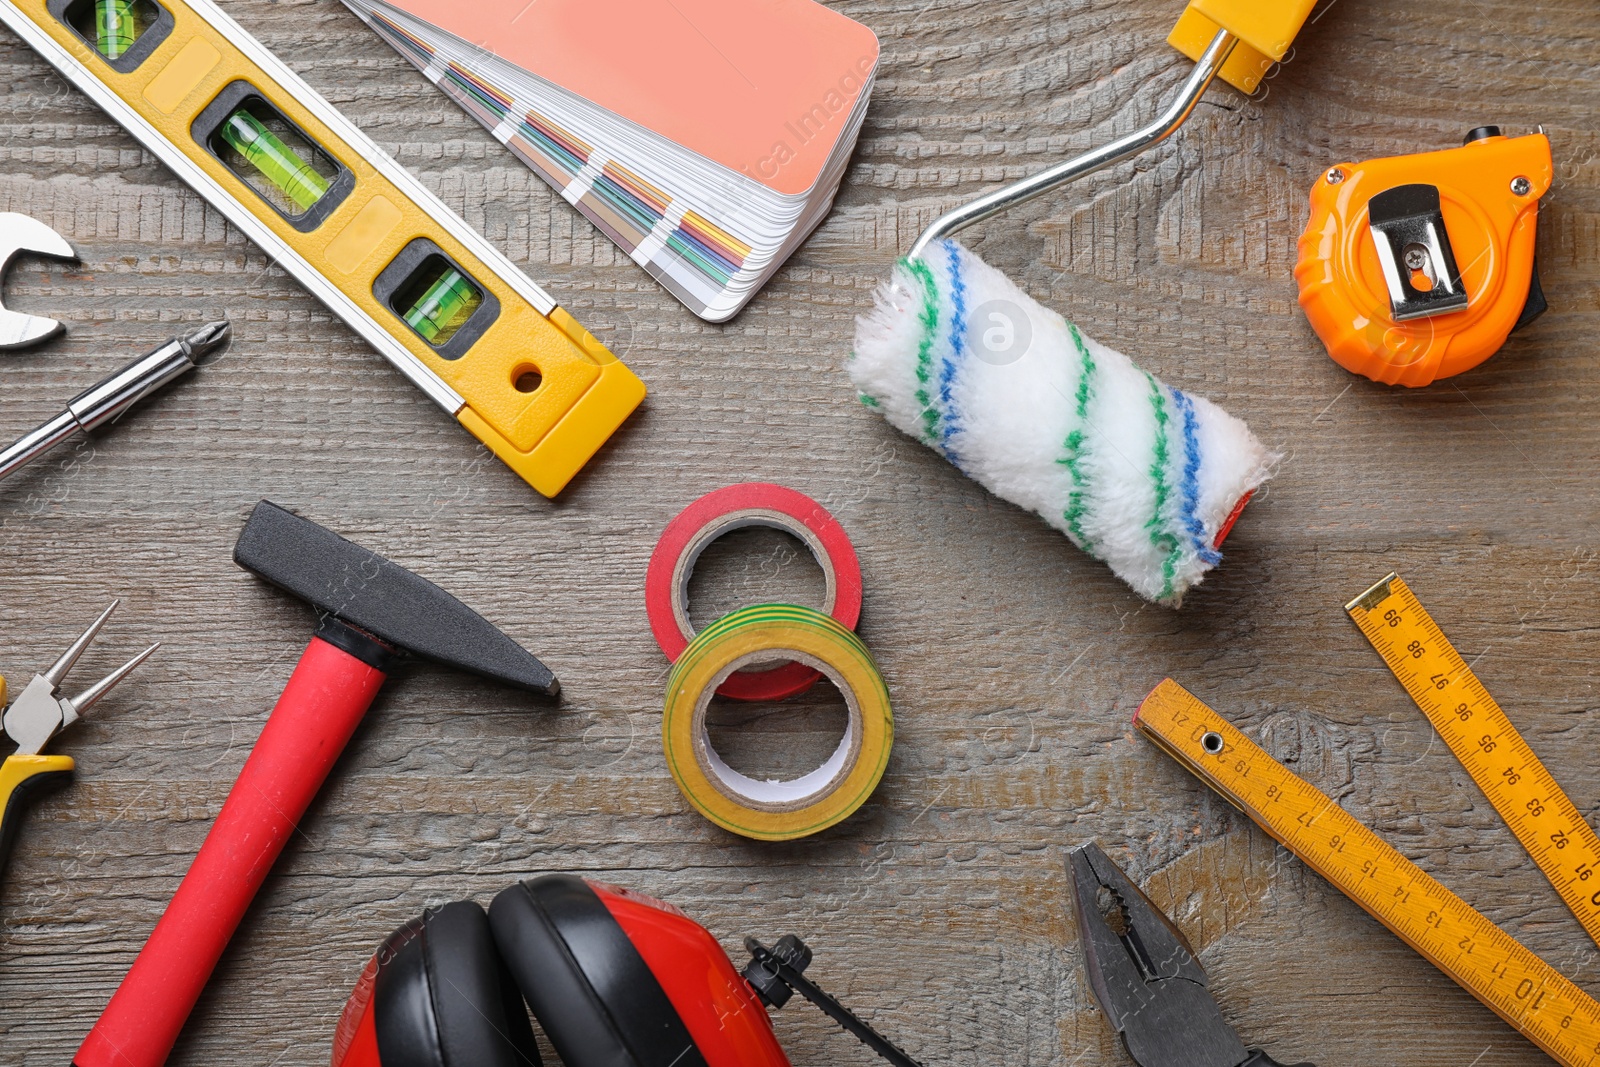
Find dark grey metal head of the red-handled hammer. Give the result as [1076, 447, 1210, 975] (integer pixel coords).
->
[234, 501, 562, 696]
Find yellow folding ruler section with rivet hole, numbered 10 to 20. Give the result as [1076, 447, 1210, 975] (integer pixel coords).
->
[1133, 678, 1600, 1067]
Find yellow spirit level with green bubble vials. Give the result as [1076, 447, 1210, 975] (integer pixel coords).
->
[0, 0, 645, 496]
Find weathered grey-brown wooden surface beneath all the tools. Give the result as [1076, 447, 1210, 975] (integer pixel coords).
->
[0, 0, 1600, 1067]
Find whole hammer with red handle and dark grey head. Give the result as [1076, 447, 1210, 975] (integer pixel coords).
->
[72, 501, 560, 1067]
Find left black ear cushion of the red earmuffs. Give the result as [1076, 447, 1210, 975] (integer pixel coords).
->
[373, 901, 541, 1067]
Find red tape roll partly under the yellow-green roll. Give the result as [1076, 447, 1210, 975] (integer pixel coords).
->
[645, 482, 861, 701]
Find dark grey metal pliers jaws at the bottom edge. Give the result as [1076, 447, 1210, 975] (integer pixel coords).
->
[1069, 841, 1270, 1067]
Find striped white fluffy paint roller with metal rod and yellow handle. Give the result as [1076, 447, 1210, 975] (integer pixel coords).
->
[850, 0, 1315, 608]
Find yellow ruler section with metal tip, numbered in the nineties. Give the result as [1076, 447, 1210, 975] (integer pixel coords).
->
[1344, 574, 1600, 942]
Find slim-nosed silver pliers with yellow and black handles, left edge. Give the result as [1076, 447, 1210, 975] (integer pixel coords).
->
[0, 600, 160, 869]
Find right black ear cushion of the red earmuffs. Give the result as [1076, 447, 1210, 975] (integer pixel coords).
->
[486, 875, 706, 1067]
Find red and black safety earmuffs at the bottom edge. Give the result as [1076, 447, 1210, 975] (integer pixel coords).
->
[333, 875, 912, 1067]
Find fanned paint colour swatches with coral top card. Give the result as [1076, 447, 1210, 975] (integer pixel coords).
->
[344, 0, 878, 322]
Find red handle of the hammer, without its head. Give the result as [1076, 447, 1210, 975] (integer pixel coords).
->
[72, 637, 386, 1067]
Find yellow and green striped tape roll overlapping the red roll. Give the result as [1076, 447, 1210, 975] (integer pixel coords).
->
[661, 605, 894, 841]
